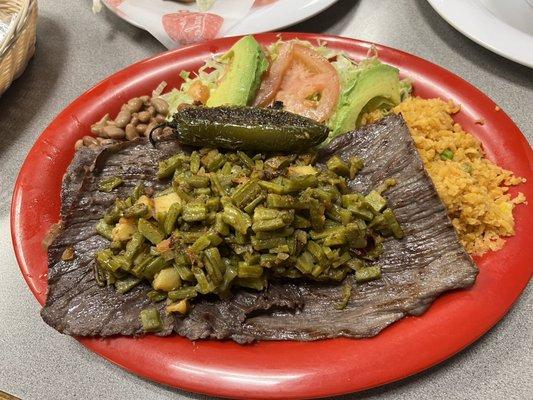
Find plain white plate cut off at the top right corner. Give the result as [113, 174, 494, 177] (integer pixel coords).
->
[428, 0, 533, 68]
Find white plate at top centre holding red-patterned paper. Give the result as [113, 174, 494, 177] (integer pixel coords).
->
[103, 0, 338, 40]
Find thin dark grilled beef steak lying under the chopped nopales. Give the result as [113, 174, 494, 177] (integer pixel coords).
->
[42, 116, 477, 342]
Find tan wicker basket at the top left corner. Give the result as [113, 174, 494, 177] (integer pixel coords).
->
[0, 0, 37, 96]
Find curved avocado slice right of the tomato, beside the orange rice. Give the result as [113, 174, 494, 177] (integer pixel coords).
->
[329, 63, 401, 139]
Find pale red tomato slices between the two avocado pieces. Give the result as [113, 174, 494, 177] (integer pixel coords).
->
[254, 42, 340, 122]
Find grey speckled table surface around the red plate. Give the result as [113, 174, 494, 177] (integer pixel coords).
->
[0, 0, 533, 399]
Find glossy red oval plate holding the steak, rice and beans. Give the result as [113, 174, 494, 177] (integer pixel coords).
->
[11, 33, 533, 399]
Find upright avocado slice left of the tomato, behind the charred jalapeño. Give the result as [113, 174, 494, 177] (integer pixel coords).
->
[206, 36, 268, 107]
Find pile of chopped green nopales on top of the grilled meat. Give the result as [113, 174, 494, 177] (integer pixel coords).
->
[90, 144, 403, 314]
